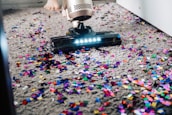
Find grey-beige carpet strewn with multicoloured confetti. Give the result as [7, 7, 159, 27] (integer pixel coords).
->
[4, 2, 172, 115]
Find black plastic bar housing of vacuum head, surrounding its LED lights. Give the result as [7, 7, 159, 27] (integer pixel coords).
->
[51, 32, 122, 53]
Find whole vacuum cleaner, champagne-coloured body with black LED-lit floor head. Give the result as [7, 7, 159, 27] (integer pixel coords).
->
[50, 0, 122, 53]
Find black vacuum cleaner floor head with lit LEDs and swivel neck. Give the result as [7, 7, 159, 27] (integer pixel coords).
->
[51, 23, 122, 53]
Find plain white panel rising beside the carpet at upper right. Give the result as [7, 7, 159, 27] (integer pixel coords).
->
[117, 0, 172, 36]
